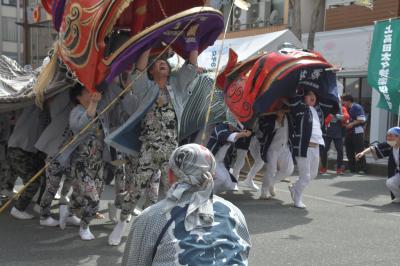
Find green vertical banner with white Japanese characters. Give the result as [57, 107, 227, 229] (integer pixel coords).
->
[368, 19, 400, 114]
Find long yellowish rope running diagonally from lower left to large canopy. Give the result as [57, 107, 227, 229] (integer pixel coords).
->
[0, 6, 205, 214]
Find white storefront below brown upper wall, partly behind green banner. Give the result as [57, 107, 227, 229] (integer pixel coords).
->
[303, 26, 397, 143]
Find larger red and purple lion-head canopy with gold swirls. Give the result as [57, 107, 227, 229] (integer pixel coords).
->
[42, 0, 224, 91]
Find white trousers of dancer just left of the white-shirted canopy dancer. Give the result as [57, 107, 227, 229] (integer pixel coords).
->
[262, 145, 294, 191]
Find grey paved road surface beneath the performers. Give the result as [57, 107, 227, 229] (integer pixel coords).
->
[0, 171, 400, 266]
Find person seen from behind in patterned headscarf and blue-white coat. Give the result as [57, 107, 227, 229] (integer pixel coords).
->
[122, 144, 251, 266]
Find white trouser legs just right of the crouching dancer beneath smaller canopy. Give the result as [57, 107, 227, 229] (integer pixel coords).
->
[233, 136, 264, 179]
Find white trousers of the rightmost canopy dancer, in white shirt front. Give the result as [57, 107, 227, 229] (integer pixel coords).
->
[293, 146, 319, 203]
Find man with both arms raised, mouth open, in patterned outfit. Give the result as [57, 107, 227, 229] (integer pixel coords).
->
[108, 49, 198, 245]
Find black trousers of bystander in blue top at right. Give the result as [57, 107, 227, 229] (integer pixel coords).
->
[345, 133, 367, 172]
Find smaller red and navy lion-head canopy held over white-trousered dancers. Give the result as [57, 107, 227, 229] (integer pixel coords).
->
[220, 50, 339, 123]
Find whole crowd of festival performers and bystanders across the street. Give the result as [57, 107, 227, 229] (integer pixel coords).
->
[0, 45, 400, 265]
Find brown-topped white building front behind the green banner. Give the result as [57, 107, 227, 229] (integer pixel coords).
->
[322, 0, 400, 143]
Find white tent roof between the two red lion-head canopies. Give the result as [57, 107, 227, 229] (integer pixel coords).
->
[198, 30, 303, 69]
